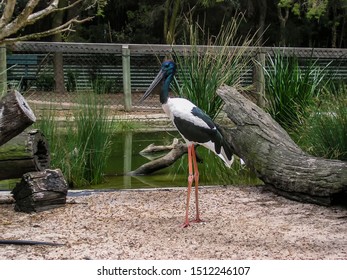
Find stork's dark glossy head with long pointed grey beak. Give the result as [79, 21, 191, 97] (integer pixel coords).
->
[139, 60, 176, 103]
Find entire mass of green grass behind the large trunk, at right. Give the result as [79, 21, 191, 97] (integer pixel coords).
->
[264, 53, 347, 160]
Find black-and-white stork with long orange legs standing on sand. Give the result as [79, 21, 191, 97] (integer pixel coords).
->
[140, 60, 233, 227]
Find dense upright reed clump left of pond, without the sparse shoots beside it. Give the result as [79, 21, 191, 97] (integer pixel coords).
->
[70, 94, 112, 185]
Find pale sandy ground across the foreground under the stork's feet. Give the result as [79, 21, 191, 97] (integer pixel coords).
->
[0, 187, 347, 260]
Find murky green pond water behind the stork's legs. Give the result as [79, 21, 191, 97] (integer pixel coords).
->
[80, 131, 260, 189]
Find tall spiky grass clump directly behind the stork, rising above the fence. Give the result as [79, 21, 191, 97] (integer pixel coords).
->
[173, 13, 253, 118]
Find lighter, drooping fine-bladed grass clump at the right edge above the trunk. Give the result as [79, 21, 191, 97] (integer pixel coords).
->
[298, 82, 347, 160]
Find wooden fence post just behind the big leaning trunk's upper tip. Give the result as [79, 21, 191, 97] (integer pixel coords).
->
[253, 50, 266, 108]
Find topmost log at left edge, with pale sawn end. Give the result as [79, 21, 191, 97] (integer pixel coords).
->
[0, 90, 36, 146]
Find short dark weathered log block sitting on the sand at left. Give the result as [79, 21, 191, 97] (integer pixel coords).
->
[12, 169, 68, 213]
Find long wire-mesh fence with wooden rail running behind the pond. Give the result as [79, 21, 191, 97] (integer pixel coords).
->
[7, 42, 347, 111]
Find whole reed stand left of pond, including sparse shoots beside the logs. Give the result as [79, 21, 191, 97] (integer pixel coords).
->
[33, 89, 114, 187]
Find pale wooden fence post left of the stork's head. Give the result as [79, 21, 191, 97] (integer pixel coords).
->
[122, 45, 131, 111]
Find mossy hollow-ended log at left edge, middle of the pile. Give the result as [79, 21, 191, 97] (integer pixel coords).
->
[0, 129, 50, 180]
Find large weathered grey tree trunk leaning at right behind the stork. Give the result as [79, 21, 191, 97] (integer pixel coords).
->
[217, 86, 347, 205]
